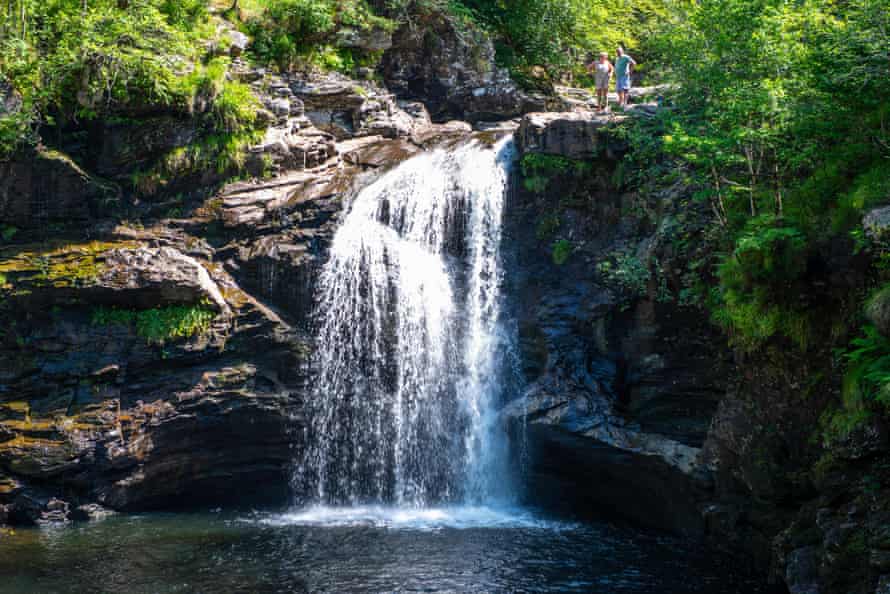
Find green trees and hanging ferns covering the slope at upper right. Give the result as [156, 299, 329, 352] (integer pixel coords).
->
[622, 0, 890, 360]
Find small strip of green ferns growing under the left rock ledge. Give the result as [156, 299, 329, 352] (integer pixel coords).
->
[92, 303, 215, 344]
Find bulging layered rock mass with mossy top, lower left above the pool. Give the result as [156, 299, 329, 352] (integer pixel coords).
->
[0, 241, 306, 524]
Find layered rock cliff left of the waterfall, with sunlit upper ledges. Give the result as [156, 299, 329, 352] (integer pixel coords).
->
[0, 38, 482, 524]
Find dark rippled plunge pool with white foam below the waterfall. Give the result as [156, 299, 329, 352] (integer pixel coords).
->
[0, 508, 763, 594]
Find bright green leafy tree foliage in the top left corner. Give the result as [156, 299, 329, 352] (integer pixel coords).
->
[0, 0, 217, 118]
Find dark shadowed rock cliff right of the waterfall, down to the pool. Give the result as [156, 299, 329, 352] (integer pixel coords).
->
[506, 106, 890, 594]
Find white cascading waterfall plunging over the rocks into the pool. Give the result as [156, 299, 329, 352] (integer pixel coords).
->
[295, 139, 514, 507]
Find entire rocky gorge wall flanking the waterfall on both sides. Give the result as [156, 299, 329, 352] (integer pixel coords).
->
[0, 9, 890, 594]
